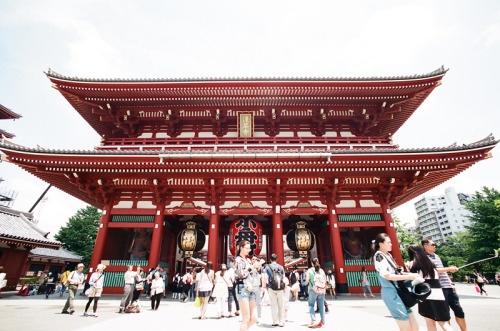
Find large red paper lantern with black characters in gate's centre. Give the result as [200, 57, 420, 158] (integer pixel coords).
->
[229, 217, 263, 256]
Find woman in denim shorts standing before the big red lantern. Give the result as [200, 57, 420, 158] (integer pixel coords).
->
[234, 240, 261, 331]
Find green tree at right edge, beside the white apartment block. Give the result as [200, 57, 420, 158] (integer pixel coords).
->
[466, 187, 500, 274]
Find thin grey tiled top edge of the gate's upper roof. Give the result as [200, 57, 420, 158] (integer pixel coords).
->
[45, 66, 448, 83]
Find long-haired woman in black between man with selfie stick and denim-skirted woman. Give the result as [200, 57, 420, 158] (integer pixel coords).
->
[407, 244, 453, 331]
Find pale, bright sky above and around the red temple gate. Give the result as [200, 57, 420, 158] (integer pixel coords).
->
[0, 0, 500, 239]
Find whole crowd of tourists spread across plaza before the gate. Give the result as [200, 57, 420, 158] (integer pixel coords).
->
[50, 233, 496, 331]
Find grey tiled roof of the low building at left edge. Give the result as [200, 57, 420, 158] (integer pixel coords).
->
[0, 206, 61, 248]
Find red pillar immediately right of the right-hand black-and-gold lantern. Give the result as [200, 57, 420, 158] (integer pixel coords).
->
[328, 204, 348, 293]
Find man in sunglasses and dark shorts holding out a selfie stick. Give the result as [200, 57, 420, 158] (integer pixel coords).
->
[421, 239, 467, 331]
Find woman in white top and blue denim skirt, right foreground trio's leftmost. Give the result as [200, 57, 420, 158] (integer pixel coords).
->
[373, 233, 418, 331]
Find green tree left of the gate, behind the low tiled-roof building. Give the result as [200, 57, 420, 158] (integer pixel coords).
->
[54, 206, 101, 266]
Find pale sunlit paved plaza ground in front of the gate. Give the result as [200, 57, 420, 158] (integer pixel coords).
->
[0, 284, 500, 331]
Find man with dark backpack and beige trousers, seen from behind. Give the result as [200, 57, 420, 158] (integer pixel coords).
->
[266, 254, 285, 326]
